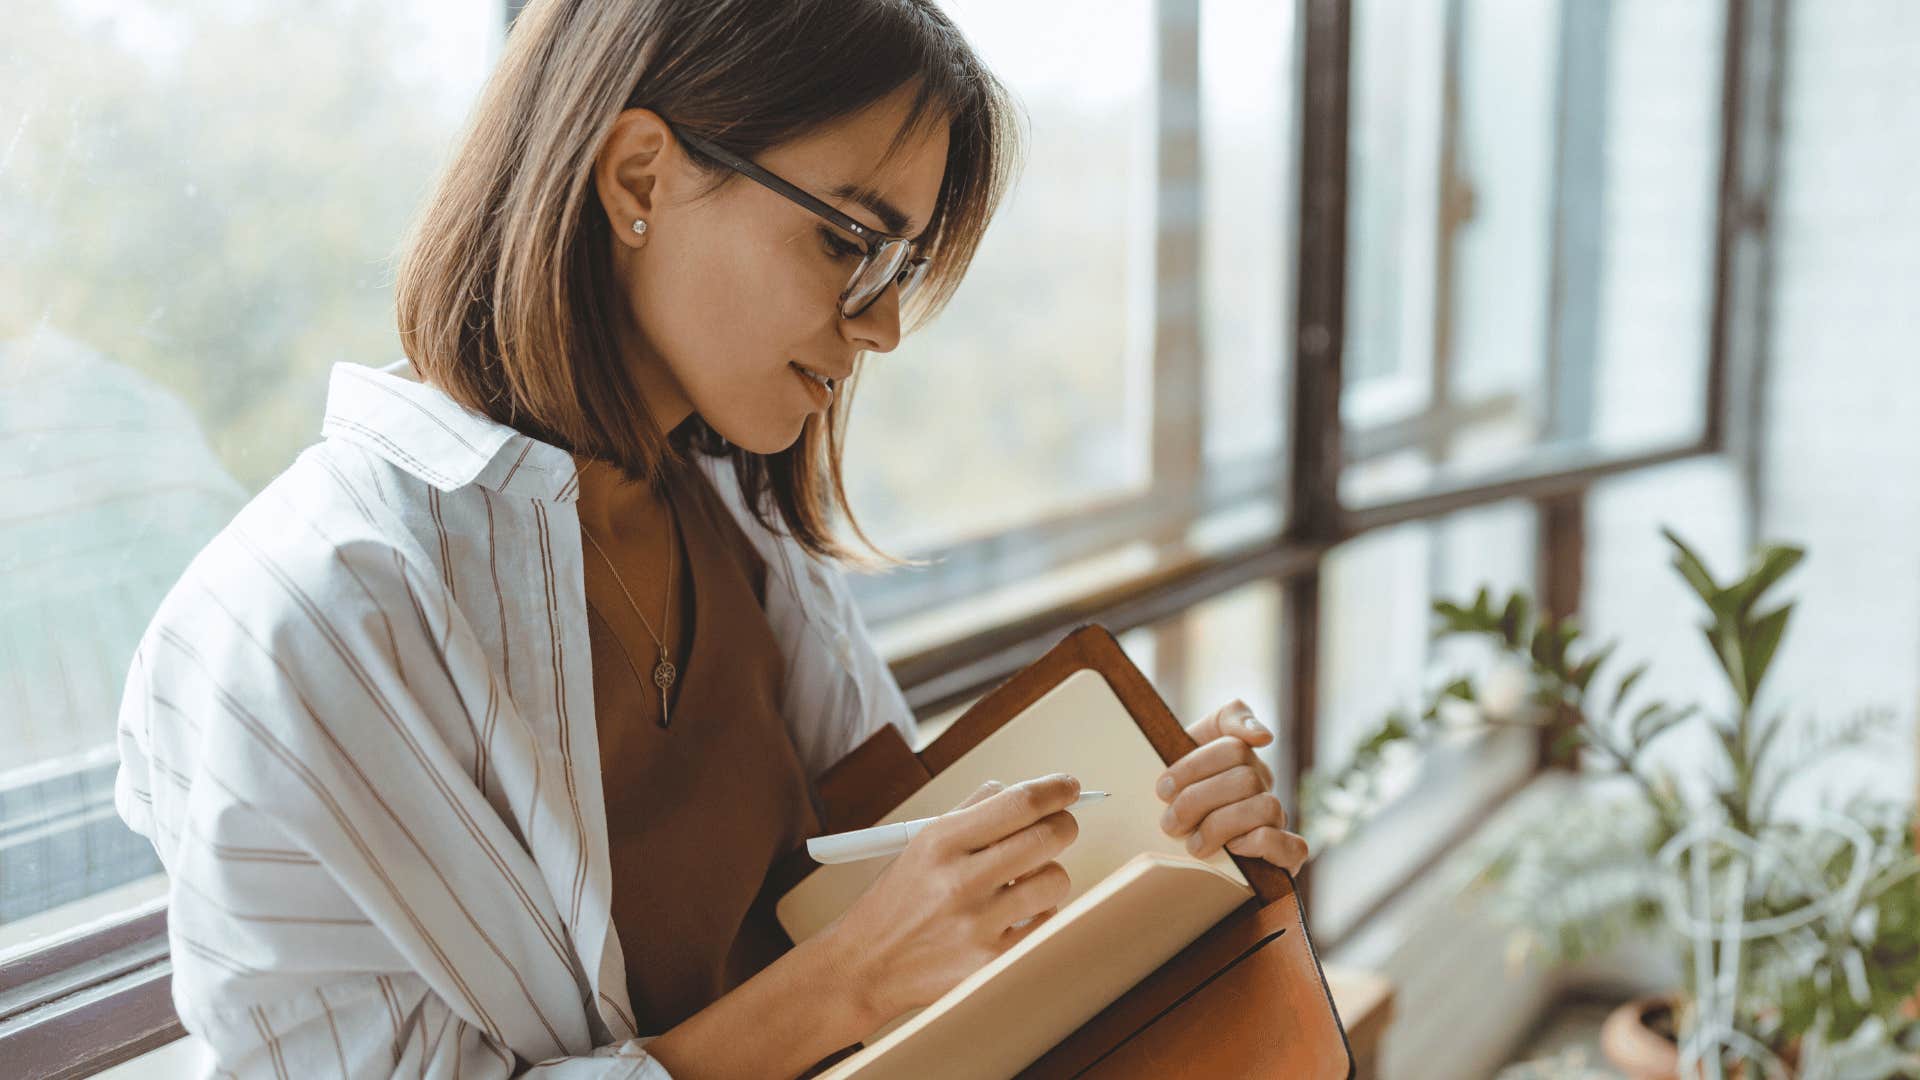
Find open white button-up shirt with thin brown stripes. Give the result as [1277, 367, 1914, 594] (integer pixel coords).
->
[115, 361, 914, 1080]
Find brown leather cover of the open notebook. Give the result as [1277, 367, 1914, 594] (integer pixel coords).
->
[768, 625, 1354, 1080]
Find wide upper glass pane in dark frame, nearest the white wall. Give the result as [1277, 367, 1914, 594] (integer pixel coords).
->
[1342, 0, 1724, 503]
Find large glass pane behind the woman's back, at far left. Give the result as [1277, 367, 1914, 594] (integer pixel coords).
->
[0, 0, 501, 955]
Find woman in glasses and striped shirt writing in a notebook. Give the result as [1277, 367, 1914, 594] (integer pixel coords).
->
[115, 0, 1304, 1080]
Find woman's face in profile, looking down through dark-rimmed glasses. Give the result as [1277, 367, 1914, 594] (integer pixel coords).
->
[595, 86, 947, 454]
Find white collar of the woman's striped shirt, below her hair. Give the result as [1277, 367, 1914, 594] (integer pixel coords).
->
[321, 359, 580, 502]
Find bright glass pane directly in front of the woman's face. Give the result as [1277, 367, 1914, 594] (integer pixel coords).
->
[847, 0, 1154, 553]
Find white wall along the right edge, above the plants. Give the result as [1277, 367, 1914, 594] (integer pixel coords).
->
[1759, 0, 1920, 792]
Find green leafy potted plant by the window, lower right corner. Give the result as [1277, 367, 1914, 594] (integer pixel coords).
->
[1302, 530, 1920, 1078]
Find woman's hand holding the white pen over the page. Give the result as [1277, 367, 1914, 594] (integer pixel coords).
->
[822, 773, 1079, 1030]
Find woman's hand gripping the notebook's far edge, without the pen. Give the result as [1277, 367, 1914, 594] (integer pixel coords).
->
[1154, 700, 1308, 872]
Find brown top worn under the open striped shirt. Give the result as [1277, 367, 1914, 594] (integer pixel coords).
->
[580, 449, 820, 1034]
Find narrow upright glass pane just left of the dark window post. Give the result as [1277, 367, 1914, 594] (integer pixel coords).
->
[1200, 0, 1298, 459]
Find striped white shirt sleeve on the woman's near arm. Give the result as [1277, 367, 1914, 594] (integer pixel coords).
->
[115, 527, 672, 1080]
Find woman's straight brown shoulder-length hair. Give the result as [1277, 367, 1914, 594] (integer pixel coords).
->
[385, 0, 1020, 567]
